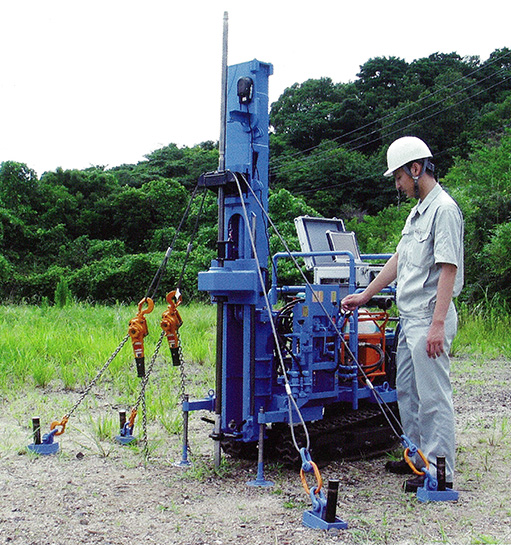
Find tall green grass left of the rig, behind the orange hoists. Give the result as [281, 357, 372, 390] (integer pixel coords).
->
[0, 304, 215, 393]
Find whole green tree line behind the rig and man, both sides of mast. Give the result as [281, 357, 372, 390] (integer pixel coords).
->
[0, 49, 511, 302]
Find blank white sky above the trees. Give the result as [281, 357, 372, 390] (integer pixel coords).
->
[0, 0, 511, 175]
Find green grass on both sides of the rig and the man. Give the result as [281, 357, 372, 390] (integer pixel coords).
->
[0, 300, 511, 400]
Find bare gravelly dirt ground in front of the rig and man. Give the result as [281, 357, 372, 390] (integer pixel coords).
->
[0, 356, 511, 545]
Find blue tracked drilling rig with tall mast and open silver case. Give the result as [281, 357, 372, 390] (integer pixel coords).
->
[192, 60, 396, 468]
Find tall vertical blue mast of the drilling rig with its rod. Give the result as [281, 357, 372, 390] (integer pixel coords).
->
[199, 42, 273, 465]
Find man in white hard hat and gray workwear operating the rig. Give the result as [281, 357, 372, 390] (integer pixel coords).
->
[342, 136, 463, 492]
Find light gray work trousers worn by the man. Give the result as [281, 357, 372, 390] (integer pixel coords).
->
[396, 303, 458, 482]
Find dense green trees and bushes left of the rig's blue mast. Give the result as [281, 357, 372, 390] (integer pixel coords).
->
[0, 143, 217, 301]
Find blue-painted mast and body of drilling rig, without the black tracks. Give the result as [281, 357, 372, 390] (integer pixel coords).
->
[198, 60, 396, 452]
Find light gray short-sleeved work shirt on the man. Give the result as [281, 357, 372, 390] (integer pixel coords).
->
[396, 184, 464, 318]
